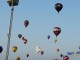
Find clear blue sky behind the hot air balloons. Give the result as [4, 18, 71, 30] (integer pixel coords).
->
[0, 0, 80, 60]
